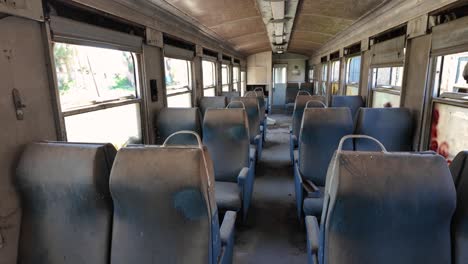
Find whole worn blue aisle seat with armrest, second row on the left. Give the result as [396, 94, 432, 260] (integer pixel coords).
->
[203, 108, 255, 220]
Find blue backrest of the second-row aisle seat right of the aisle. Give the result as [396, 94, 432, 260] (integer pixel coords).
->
[298, 108, 353, 186]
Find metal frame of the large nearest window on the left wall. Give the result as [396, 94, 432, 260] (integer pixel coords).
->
[46, 38, 149, 144]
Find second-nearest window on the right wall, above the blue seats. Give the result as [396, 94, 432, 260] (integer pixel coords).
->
[372, 67, 403, 108]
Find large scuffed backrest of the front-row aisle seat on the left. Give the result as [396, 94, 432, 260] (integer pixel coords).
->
[110, 141, 220, 264]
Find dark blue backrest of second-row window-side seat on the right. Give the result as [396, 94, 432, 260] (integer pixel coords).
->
[354, 108, 413, 151]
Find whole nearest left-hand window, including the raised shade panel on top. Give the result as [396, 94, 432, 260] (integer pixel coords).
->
[51, 16, 143, 149]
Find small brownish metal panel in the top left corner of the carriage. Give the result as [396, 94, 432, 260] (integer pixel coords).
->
[0, 0, 44, 21]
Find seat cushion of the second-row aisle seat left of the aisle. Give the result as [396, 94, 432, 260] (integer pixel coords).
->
[215, 181, 242, 211]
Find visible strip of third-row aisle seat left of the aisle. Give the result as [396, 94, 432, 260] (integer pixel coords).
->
[229, 96, 263, 161]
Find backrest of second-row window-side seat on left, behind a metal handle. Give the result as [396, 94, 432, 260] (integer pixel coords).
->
[156, 107, 202, 145]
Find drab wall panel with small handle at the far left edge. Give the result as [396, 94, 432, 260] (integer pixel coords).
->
[0, 17, 56, 264]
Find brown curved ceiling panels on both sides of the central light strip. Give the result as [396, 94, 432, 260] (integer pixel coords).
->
[155, 0, 388, 55]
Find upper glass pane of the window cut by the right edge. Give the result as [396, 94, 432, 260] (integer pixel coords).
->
[435, 52, 468, 95]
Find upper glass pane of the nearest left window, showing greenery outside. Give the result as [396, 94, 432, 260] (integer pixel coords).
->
[53, 43, 138, 111]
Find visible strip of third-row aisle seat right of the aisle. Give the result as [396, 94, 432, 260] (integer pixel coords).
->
[289, 94, 326, 162]
